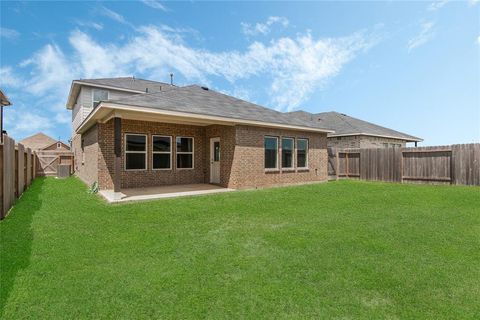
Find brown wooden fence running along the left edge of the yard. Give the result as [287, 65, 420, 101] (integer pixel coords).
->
[0, 135, 36, 219]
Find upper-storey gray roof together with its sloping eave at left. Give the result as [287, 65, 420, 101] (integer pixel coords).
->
[67, 77, 173, 109]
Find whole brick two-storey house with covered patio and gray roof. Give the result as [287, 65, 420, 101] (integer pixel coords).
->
[67, 78, 332, 196]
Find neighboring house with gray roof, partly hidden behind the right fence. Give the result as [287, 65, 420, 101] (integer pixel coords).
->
[290, 111, 423, 148]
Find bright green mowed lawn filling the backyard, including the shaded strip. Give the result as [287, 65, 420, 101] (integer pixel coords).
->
[0, 178, 480, 319]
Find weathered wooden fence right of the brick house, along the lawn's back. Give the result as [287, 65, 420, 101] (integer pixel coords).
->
[328, 143, 480, 185]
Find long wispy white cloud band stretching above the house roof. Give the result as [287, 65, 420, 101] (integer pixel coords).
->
[1, 22, 378, 137]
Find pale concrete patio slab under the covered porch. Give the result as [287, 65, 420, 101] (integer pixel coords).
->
[99, 184, 235, 203]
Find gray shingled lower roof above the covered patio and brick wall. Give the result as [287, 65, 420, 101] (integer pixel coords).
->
[108, 85, 328, 130]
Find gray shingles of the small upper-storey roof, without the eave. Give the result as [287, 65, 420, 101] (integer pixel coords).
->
[75, 77, 172, 92]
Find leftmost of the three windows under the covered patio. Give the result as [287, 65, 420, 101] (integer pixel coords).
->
[125, 134, 147, 170]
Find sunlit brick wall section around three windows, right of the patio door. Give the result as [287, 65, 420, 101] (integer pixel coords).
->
[229, 126, 328, 188]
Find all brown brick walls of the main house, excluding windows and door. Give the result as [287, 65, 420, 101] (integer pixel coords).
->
[73, 120, 327, 190]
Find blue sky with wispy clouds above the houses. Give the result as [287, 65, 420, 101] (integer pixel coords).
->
[0, 0, 480, 145]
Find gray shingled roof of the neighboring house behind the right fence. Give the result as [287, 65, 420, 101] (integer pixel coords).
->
[289, 111, 422, 141]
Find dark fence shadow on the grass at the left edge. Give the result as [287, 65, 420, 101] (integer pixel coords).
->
[0, 178, 45, 317]
